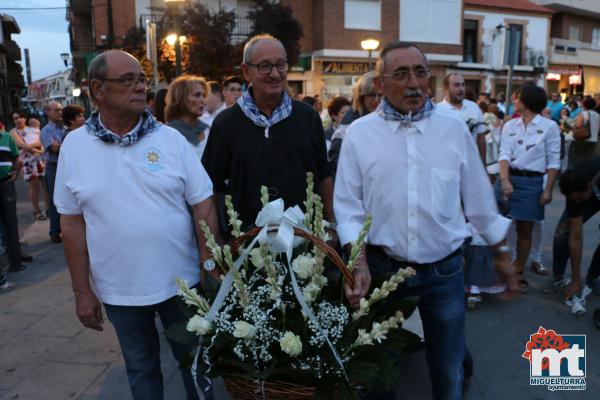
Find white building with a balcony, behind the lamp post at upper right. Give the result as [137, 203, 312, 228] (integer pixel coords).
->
[460, 0, 554, 96]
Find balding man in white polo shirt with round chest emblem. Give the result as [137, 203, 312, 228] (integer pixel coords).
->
[54, 50, 216, 400]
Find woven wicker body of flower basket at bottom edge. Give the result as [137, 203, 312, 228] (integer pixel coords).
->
[223, 376, 315, 400]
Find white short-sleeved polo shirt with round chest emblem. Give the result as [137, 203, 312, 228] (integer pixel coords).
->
[54, 125, 212, 306]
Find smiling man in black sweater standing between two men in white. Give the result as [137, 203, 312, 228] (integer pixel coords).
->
[202, 35, 334, 248]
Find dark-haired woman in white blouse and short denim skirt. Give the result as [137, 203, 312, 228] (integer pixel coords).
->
[496, 83, 560, 292]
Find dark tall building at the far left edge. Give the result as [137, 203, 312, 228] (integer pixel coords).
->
[0, 13, 25, 126]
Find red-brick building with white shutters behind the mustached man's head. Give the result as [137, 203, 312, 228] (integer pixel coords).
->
[282, 0, 463, 100]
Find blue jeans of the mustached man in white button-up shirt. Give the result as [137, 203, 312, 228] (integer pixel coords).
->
[367, 246, 466, 400]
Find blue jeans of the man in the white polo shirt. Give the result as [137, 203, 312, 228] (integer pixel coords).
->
[104, 297, 199, 400]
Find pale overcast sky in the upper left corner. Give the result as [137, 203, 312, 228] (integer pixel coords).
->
[0, 0, 69, 80]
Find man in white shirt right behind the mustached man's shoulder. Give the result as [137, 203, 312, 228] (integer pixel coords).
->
[438, 72, 487, 163]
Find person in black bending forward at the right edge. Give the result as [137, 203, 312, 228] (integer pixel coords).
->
[546, 156, 600, 308]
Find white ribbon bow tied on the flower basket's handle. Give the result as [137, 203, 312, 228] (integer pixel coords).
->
[255, 199, 306, 260]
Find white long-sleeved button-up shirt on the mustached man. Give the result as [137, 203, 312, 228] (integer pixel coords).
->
[334, 107, 510, 263]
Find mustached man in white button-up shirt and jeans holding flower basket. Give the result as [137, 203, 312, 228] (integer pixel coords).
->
[334, 42, 510, 399]
